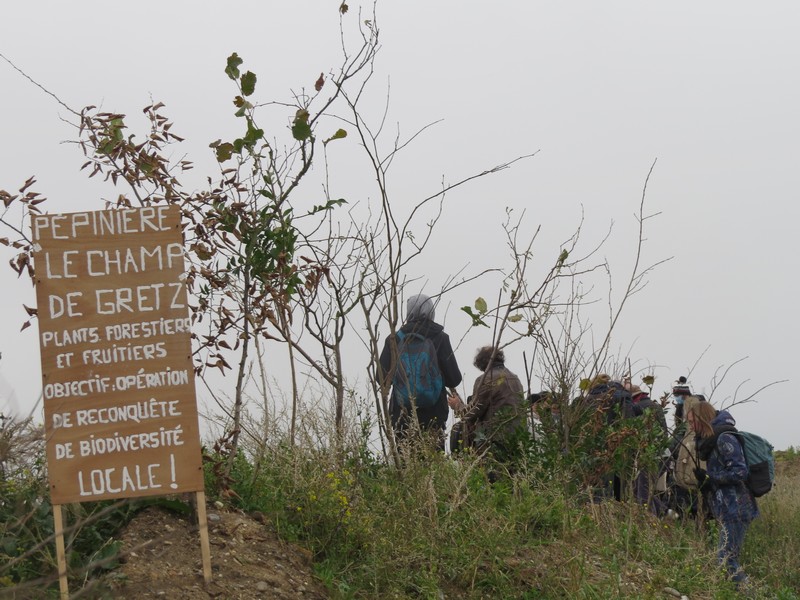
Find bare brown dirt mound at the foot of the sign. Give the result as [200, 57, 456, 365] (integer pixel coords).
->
[106, 507, 327, 600]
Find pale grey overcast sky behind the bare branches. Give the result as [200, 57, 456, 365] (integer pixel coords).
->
[0, 0, 800, 448]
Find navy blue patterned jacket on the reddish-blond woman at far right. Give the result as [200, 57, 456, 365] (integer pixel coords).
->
[696, 410, 759, 523]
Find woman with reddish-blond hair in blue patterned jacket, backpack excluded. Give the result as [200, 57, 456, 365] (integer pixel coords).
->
[686, 402, 759, 585]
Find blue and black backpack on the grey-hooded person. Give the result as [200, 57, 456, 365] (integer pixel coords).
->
[392, 331, 444, 408]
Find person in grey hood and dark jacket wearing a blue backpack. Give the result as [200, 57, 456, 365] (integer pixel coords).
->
[380, 294, 461, 450]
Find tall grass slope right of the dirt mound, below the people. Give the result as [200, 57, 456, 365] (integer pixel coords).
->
[205, 428, 800, 600]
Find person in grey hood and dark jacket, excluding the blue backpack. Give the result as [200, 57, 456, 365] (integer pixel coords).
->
[380, 294, 461, 450]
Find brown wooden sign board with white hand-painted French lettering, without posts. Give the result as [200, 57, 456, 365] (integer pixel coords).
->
[31, 206, 203, 504]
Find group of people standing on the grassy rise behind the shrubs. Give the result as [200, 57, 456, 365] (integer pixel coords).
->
[380, 294, 758, 582]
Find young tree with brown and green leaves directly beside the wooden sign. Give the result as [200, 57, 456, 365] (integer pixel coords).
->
[0, 3, 378, 478]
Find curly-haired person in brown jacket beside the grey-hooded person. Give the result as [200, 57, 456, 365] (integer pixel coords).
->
[447, 346, 527, 463]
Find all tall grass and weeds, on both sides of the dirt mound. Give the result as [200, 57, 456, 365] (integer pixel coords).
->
[0, 410, 800, 600]
